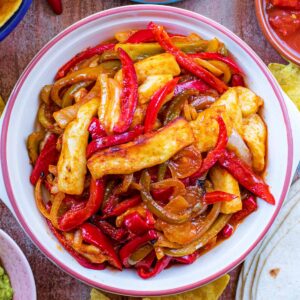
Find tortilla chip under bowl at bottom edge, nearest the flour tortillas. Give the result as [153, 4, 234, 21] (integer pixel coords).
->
[143, 274, 230, 300]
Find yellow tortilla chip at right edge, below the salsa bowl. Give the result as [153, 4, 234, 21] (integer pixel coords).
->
[269, 63, 300, 110]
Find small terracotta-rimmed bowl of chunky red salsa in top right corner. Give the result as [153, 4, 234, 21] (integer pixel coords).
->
[255, 0, 300, 65]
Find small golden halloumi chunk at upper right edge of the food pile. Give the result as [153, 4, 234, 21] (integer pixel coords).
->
[234, 86, 264, 117]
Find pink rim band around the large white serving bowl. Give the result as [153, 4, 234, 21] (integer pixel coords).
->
[0, 5, 293, 297]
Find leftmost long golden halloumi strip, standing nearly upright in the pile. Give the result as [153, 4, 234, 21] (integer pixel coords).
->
[57, 98, 99, 195]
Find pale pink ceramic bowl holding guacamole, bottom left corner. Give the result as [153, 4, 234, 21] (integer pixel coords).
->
[0, 229, 36, 300]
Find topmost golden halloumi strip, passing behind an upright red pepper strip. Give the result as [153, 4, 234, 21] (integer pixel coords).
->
[115, 53, 180, 84]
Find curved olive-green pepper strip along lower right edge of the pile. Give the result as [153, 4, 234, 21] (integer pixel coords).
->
[163, 214, 231, 257]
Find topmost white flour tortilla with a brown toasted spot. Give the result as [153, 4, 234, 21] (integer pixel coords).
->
[255, 223, 300, 300]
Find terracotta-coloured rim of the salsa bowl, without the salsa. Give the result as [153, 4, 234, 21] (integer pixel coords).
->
[255, 0, 300, 65]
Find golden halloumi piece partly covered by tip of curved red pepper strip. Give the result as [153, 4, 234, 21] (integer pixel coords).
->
[190, 89, 243, 152]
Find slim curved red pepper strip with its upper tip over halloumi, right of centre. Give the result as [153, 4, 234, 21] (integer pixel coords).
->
[191, 116, 228, 181]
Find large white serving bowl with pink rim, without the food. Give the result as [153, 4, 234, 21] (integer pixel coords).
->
[1, 5, 293, 296]
